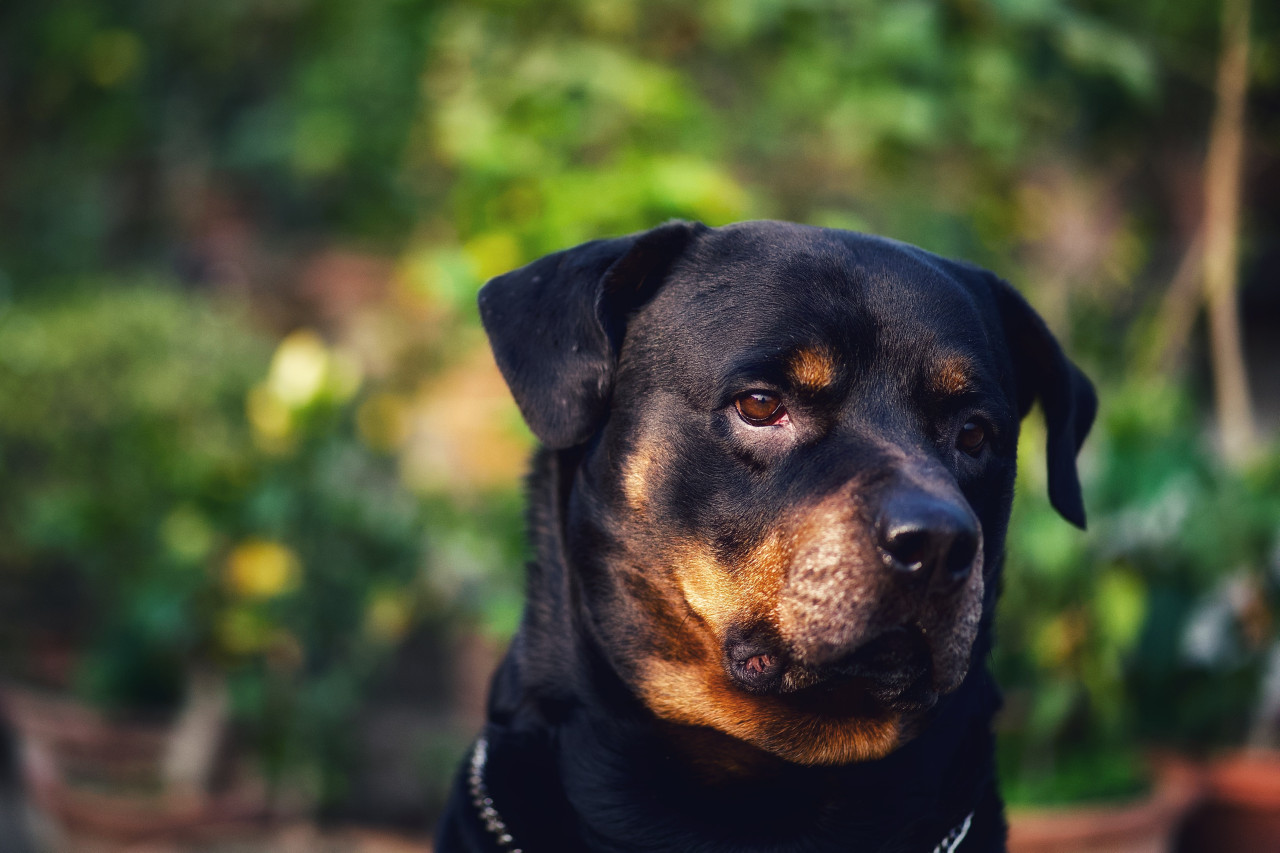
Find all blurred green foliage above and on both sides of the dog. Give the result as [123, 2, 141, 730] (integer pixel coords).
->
[0, 0, 1280, 819]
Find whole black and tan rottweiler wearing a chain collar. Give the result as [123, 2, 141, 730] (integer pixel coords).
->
[436, 222, 1096, 853]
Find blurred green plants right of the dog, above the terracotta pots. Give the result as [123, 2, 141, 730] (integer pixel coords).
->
[995, 380, 1280, 803]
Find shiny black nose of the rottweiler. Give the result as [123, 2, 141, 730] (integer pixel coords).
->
[877, 492, 978, 583]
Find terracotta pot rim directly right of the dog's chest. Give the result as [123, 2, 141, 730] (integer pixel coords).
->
[1009, 762, 1198, 853]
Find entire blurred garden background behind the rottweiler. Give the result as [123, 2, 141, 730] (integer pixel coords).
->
[0, 0, 1280, 852]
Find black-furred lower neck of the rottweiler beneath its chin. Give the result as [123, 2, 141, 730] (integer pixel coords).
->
[485, 678, 1002, 853]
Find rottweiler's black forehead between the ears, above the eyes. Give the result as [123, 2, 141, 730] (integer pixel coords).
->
[632, 222, 991, 383]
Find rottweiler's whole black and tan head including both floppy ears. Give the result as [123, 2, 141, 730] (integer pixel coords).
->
[480, 223, 1094, 765]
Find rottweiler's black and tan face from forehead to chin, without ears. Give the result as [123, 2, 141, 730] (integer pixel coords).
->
[570, 227, 1018, 765]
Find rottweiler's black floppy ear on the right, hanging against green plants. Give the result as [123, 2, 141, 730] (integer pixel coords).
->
[988, 274, 1098, 529]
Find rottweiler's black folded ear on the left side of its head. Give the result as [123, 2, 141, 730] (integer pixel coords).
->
[479, 222, 707, 450]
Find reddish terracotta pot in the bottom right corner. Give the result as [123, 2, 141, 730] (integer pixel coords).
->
[1176, 751, 1280, 853]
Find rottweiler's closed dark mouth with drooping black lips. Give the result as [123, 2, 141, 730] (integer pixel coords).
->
[726, 625, 938, 717]
